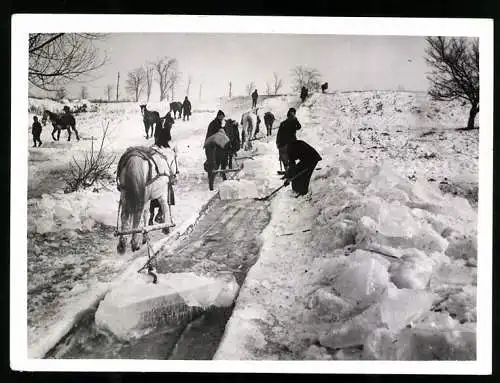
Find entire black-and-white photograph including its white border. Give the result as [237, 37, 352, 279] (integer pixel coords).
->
[10, 14, 493, 374]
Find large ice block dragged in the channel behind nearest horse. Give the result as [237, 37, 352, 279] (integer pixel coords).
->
[95, 273, 239, 339]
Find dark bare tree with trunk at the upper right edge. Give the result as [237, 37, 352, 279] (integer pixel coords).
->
[425, 36, 479, 129]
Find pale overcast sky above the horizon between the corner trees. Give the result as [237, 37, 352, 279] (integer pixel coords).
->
[28, 33, 434, 101]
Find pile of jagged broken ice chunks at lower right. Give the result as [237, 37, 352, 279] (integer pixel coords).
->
[306, 162, 477, 360]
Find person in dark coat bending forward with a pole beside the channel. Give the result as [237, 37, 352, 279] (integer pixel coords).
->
[285, 140, 322, 197]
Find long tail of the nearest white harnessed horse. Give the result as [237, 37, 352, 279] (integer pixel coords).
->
[121, 156, 146, 213]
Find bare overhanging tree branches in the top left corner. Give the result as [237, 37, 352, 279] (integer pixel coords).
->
[28, 33, 106, 91]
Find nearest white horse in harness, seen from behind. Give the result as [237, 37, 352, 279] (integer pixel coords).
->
[117, 141, 179, 253]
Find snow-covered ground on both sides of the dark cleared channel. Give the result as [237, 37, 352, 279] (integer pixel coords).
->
[28, 92, 478, 359]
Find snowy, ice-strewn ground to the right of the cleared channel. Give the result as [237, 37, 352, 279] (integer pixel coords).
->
[214, 92, 478, 360]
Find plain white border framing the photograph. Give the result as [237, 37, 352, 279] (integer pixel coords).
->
[10, 14, 493, 375]
